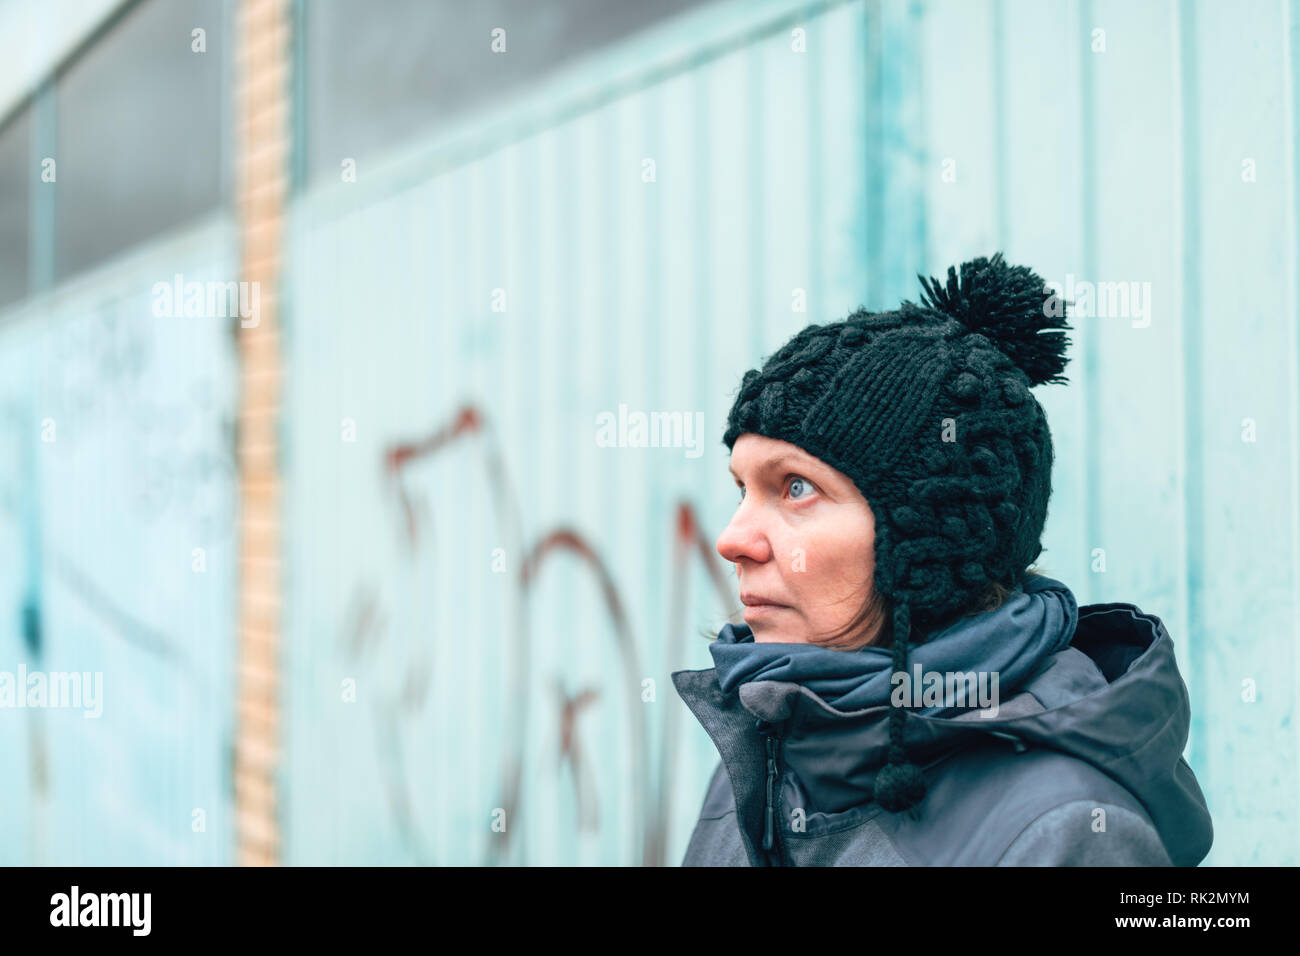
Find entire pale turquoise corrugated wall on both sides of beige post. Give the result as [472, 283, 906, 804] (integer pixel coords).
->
[0, 0, 1300, 865]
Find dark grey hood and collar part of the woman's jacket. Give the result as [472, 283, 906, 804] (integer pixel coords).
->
[672, 604, 1213, 866]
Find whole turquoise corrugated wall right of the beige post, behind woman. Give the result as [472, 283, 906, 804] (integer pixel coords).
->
[286, 0, 1300, 864]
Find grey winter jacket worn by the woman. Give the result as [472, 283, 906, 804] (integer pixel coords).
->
[672, 604, 1213, 866]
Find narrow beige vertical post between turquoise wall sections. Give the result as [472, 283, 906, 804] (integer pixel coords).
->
[234, 0, 291, 866]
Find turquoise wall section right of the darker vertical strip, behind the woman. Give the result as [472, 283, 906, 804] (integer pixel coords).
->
[923, 1, 1300, 865]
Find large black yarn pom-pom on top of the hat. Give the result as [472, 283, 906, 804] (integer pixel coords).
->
[917, 252, 1071, 386]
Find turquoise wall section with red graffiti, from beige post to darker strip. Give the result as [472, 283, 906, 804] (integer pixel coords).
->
[286, 4, 889, 864]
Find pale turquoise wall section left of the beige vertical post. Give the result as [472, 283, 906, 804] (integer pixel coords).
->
[0, 222, 238, 866]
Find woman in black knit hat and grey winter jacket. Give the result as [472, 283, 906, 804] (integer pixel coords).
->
[673, 254, 1213, 866]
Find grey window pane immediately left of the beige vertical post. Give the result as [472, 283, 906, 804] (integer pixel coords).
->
[53, 0, 234, 280]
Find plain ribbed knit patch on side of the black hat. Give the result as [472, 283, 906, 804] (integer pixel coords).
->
[803, 330, 950, 475]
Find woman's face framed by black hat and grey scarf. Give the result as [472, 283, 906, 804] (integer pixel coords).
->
[718, 433, 880, 646]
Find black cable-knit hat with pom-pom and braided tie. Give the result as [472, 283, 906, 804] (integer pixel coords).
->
[723, 252, 1071, 813]
